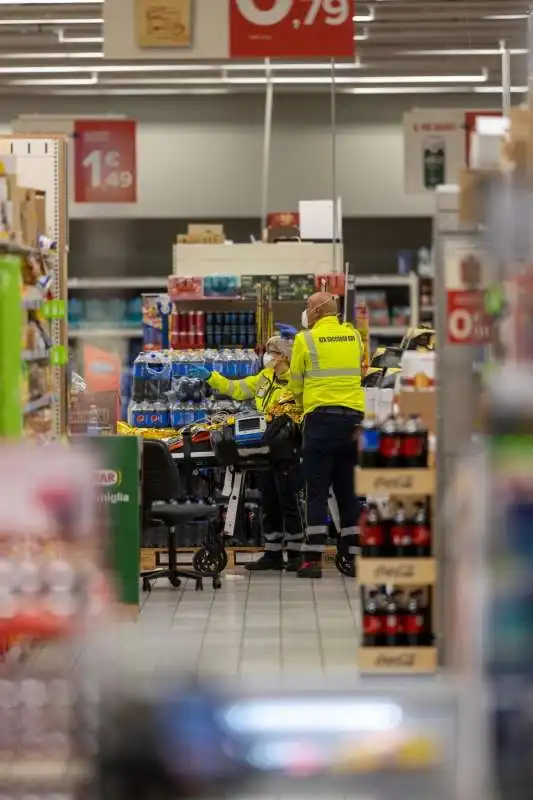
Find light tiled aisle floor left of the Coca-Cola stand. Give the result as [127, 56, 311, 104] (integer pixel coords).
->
[138, 569, 358, 681]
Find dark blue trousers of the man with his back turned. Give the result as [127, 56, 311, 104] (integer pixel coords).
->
[302, 407, 363, 561]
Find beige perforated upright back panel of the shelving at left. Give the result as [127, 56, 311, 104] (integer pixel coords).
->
[0, 133, 68, 437]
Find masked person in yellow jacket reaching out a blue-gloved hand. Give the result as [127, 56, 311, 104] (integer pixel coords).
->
[188, 336, 304, 572]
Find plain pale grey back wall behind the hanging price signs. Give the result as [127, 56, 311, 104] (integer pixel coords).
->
[0, 94, 498, 221]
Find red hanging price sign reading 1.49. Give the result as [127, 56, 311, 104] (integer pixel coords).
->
[74, 119, 137, 203]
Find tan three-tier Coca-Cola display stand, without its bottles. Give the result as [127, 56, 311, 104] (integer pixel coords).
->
[355, 467, 438, 675]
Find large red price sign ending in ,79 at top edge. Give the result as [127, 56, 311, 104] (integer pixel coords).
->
[230, 0, 354, 58]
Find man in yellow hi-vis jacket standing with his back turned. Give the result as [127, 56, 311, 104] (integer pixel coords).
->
[290, 292, 365, 578]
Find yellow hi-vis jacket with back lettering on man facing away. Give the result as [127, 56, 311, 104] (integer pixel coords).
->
[290, 316, 365, 415]
